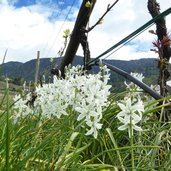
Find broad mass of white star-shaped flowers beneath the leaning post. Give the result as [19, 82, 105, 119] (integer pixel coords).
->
[14, 66, 111, 138]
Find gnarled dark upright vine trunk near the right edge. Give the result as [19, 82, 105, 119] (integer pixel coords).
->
[148, 0, 171, 97]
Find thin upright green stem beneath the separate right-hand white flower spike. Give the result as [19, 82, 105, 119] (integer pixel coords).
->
[130, 117, 135, 171]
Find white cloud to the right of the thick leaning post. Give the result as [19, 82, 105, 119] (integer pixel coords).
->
[75, 0, 171, 60]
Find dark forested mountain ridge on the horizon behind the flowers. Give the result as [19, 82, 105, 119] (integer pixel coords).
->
[0, 56, 161, 89]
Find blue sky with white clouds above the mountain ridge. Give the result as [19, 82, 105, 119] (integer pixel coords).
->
[0, 0, 171, 63]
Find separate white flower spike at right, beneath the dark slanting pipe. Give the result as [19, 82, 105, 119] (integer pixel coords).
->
[116, 73, 144, 137]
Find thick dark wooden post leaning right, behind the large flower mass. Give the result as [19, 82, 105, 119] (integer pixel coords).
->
[60, 0, 96, 77]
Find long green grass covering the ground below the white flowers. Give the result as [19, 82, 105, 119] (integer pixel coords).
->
[0, 87, 171, 171]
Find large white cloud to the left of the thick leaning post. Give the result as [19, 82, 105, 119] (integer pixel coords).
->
[0, 2, 76, 62]
